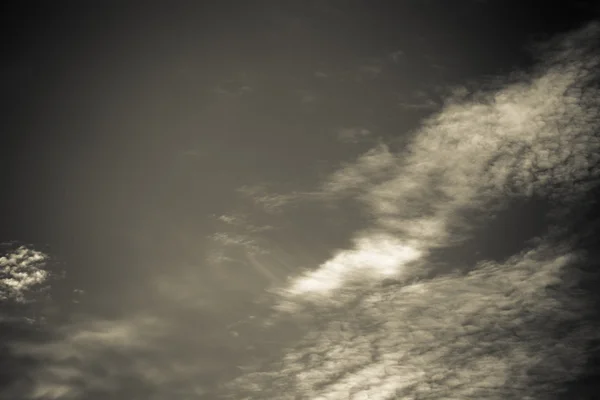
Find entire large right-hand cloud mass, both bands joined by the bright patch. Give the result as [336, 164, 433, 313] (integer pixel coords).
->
[219, 25, 600, 400]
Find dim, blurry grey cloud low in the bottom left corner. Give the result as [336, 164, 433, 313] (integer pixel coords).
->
[9, 316, 183, 399]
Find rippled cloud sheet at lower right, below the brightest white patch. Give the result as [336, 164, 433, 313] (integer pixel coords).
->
[224, 242, 597, 400]
